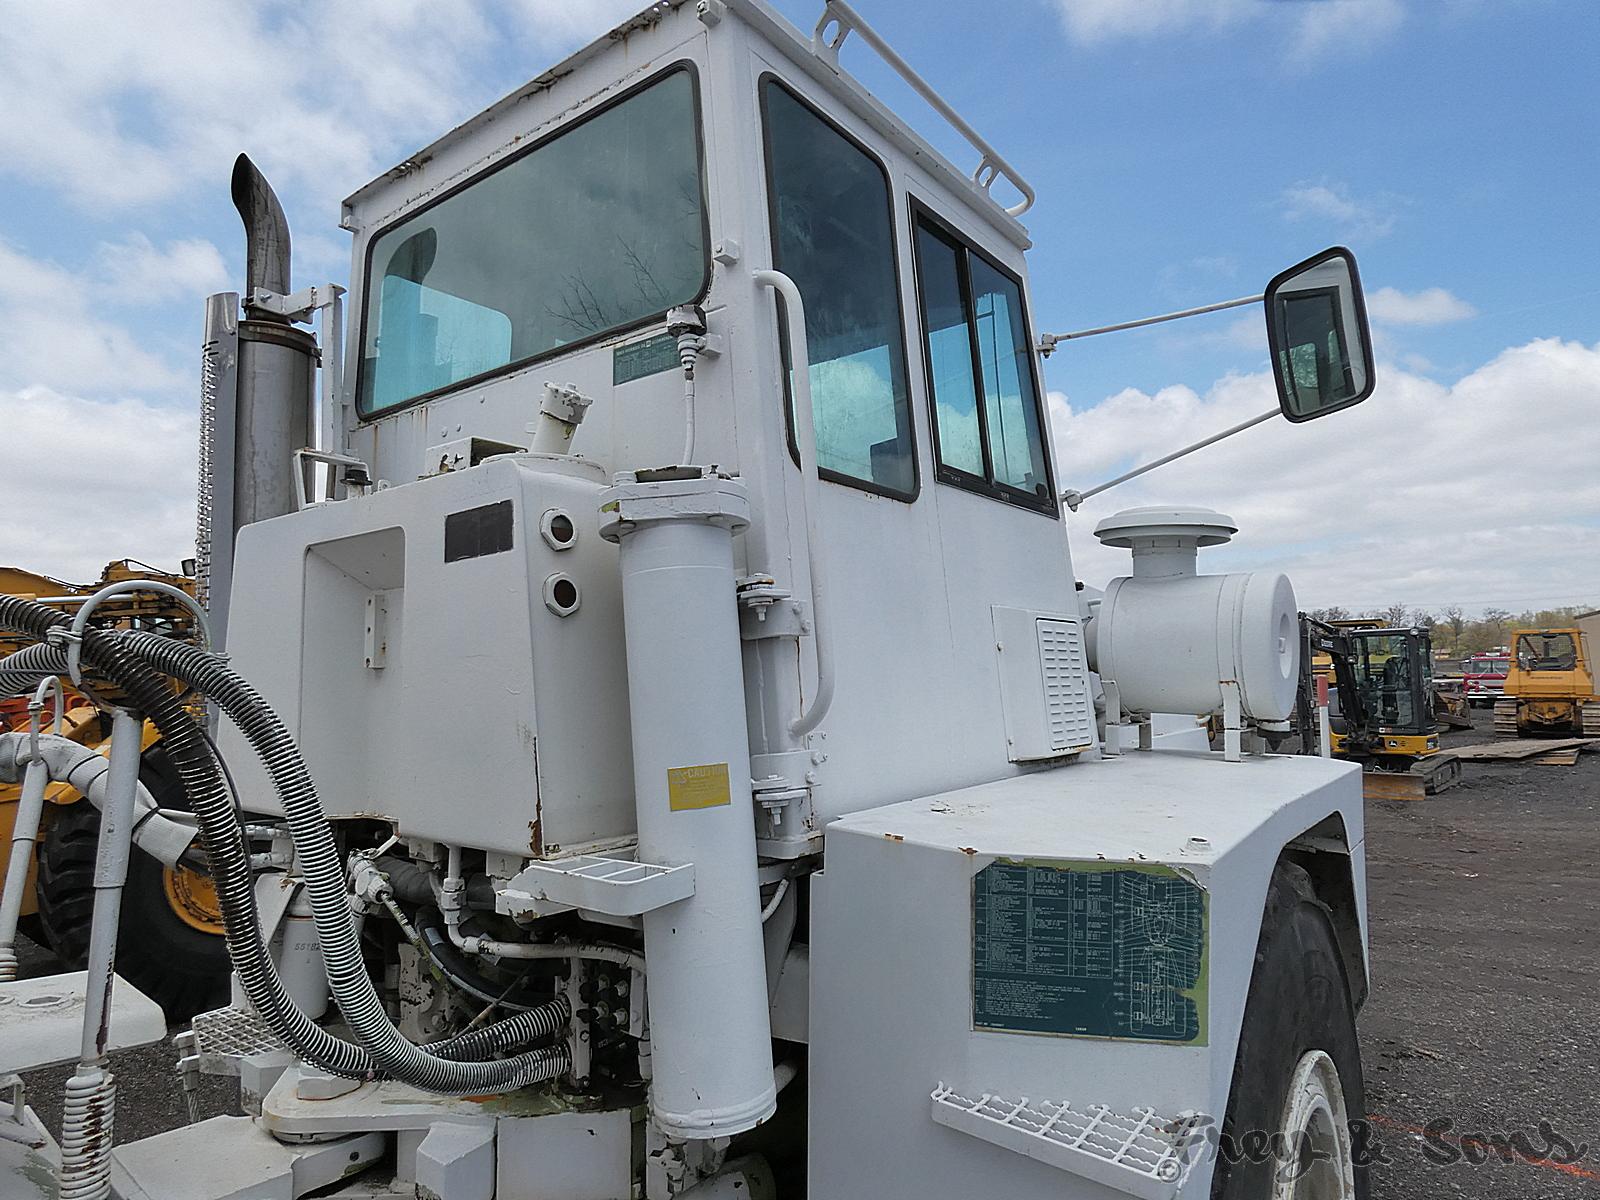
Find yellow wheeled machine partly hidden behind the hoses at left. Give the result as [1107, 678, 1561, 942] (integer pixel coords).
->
[0, 560, 229, 1021]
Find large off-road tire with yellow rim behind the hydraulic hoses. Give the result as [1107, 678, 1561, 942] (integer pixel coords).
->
[38, 755, 229, 1022]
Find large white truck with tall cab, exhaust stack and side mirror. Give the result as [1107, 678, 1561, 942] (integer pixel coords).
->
[0, 0, 1373, 1200]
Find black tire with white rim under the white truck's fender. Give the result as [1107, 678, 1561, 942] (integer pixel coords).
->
[1211, 862, 1368, 1200]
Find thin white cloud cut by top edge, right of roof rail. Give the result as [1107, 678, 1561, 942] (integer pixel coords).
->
[1056, 0, 1405, 61]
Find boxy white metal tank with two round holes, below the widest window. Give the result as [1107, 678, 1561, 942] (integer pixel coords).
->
[222, 458, 634, 856]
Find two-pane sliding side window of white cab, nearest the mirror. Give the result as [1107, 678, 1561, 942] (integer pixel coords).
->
[914, 208, 1056, 514]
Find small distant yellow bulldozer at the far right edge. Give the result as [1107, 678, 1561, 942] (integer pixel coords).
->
[1494, 627, 1600, 738]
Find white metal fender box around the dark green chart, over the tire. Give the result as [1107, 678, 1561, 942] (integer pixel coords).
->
[810, 750, 1363, 1200]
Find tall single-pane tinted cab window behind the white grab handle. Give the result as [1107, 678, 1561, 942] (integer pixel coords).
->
[762, 80, 917, 498]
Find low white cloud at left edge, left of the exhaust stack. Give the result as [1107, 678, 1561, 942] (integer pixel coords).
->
[0, 387, 198, 582]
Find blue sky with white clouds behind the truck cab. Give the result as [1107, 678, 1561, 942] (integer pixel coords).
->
[0, 0, 1600, 613]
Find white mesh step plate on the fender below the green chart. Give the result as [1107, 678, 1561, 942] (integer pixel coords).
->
[933, 1083, 1205, 1200]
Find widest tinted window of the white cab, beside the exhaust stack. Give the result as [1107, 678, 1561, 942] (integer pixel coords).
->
[358, 70, 707, 413]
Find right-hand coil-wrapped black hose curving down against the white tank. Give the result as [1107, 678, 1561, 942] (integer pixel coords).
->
[114, 632, 568, 1094]
